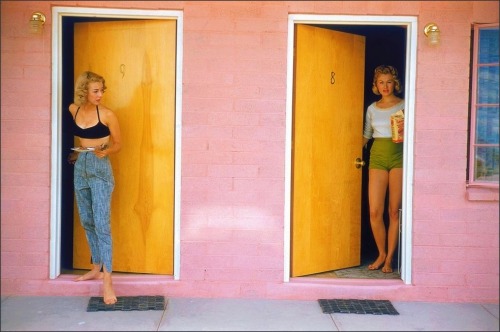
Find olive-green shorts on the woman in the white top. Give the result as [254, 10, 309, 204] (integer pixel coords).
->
[368, 138, 403, 171]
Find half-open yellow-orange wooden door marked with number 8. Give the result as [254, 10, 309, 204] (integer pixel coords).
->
[291, 25, 365, 276]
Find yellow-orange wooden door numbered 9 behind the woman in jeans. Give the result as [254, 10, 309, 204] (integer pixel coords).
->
[73, 20, 176, 274]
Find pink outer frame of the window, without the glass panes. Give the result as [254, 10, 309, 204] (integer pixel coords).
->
[468, 23, 499, 188]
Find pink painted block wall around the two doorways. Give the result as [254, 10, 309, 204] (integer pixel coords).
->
[1, 1, 499, 303]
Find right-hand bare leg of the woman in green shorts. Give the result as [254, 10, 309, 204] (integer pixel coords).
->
[382, 168, 403, 273]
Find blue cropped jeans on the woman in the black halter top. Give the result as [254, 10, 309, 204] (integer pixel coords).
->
[74, 152, 115, 272]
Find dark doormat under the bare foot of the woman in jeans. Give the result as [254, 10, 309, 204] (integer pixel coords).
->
[87, 296, 165, 312]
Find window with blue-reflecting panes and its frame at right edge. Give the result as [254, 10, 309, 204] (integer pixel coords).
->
[468, 23, 499, 187]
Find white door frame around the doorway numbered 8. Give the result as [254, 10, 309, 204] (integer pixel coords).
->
[283, 14, 418, 284]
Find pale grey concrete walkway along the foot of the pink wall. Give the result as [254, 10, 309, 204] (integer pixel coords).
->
[1, 296, 499, 331]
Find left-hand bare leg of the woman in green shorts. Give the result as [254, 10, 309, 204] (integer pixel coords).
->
[368, 169, 389, 270]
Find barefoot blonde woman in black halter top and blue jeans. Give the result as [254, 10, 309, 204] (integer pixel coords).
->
[69, 71, 121, 304]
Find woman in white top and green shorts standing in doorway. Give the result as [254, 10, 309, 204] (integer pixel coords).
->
[363, 65, 404, 273]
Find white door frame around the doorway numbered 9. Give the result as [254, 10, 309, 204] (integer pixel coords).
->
[49, 7, 183, 280]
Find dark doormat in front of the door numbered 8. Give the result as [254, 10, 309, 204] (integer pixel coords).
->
[318, 299, 399, 315]
